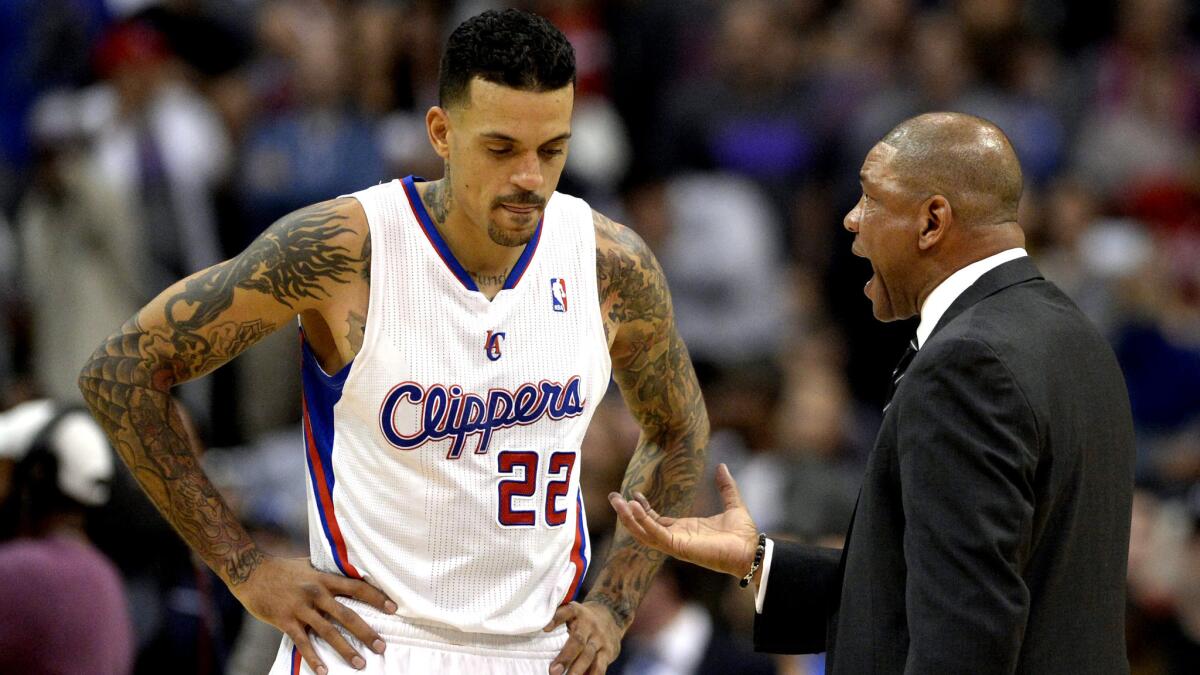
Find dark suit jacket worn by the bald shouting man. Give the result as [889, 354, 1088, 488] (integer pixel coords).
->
[755, 258, 1134, 675]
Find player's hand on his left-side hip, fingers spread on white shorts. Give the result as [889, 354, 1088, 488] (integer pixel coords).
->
[230, 556, 396, 675]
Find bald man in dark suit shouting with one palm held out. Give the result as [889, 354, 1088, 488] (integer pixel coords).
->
[610, 113, 1134, 674]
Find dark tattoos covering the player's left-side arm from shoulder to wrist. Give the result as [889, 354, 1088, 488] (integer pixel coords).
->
[79, 198, 359, 585]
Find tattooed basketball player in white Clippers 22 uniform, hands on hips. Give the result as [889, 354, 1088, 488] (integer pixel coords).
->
[80, 10, 708, 674]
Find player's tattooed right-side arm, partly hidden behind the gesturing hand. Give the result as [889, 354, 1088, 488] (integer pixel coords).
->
[551, 213, 708, 673]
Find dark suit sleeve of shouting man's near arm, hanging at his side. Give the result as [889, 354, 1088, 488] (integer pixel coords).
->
[895, 340, 1038, 674]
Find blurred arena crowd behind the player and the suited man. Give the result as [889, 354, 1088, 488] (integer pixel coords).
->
[0, 0, 1200, 675]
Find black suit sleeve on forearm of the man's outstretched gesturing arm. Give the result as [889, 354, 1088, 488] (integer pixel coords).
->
[754, 540, 841, 653]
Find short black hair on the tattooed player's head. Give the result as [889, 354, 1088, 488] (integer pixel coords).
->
[438, 10, 575, 107]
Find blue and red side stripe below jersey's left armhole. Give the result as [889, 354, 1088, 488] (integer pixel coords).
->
[300, 330, 362, 579]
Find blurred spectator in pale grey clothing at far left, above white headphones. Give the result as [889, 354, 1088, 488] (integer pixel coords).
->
[17, 90, 141, 401]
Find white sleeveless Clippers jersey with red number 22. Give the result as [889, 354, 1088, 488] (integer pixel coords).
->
[302, 177, 611, 634]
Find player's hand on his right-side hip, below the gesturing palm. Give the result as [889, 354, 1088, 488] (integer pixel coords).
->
[542, 601, 624, 675]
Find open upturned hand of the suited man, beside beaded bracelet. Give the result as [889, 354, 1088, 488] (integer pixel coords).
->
[608, 464, 758, 578]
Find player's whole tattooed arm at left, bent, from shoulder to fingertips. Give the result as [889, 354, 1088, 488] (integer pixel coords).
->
[79, 199, 386, 669]
